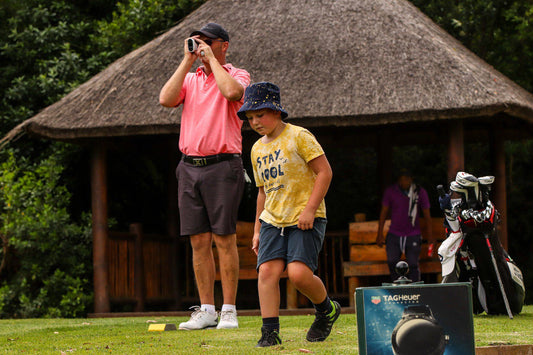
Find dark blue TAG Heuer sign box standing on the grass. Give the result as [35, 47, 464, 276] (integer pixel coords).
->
[355, 283, 475, 355]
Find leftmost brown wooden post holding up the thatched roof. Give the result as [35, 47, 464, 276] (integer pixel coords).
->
[91, 142, 110, 313]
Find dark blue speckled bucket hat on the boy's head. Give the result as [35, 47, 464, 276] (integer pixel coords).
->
[237, 81, 289, 120]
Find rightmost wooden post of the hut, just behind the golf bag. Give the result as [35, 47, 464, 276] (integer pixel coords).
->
[490, 126, 508, 250]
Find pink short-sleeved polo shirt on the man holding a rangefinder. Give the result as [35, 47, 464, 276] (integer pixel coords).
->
[179, 64, 250, 156]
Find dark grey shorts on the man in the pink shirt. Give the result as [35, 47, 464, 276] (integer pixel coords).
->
[176, 157, 244, 235]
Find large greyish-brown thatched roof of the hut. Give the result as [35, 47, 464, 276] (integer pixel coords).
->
[4, 0, 533, 139]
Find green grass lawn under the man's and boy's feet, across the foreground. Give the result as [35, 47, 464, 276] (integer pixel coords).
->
[0, 306, 533, 354]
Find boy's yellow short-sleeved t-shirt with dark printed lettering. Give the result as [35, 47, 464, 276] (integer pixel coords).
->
[251, 124, 326, 227]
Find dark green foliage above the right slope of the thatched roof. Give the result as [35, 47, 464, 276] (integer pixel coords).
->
[412, 0, 533, 91]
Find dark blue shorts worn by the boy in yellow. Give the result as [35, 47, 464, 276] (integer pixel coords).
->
[257, 218, 327, 272]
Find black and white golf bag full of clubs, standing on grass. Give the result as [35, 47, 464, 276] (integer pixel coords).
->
[437, 172, 525, 318]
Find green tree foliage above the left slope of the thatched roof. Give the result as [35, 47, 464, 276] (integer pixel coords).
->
[0, 0, 202, 134]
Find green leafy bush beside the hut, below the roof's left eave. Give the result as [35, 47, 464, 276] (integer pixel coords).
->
[0, 146, 92, 317]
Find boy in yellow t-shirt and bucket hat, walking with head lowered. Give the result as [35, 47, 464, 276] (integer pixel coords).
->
[237, 82, 341, 347]
